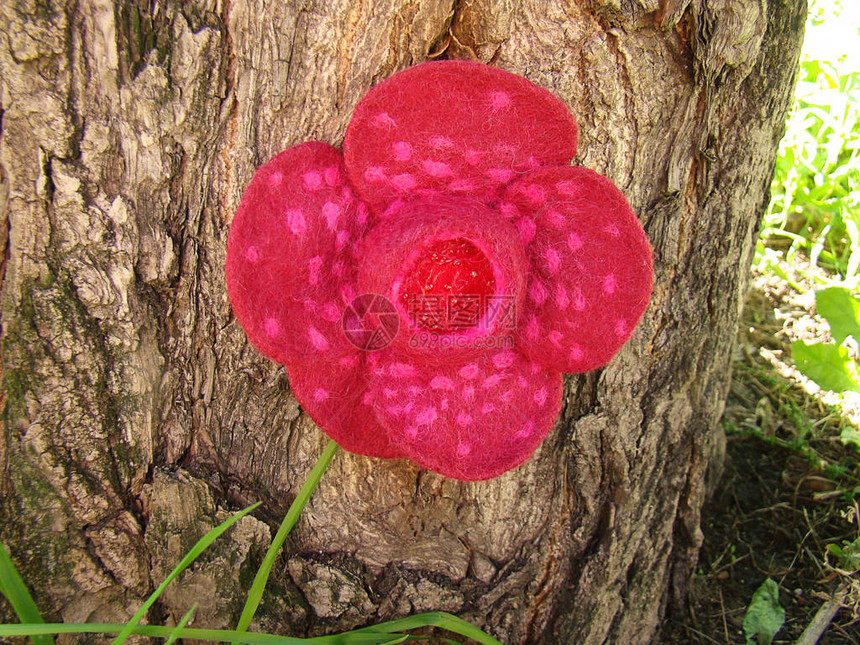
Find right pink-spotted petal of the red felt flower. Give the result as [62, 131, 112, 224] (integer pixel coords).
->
[502, 167, 653, 373]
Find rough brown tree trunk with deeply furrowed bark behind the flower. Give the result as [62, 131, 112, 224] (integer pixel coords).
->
[0, 0, 806, 643]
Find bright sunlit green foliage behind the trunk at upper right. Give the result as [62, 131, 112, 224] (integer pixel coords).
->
[757, 0, 860, 286]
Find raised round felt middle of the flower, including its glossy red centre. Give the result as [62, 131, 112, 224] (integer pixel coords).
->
[357, 196, 528, 363]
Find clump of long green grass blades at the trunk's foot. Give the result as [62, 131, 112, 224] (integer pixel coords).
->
[0, 441, 501, 645]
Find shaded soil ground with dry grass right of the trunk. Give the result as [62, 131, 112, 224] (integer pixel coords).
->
[663, 267, 860, 644]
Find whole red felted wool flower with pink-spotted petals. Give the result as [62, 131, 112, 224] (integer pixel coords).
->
[226, 61, 652, 480]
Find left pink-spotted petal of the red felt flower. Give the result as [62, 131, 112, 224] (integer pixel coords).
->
[226, 143, 368, 366]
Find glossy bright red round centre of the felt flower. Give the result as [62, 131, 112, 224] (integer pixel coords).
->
[401, 237, 496, 333]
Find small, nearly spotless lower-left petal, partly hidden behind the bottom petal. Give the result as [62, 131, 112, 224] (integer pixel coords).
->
[287, 352, 405, 459]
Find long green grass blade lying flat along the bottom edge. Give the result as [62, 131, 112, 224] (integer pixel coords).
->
[0, 623, 404, 645]
